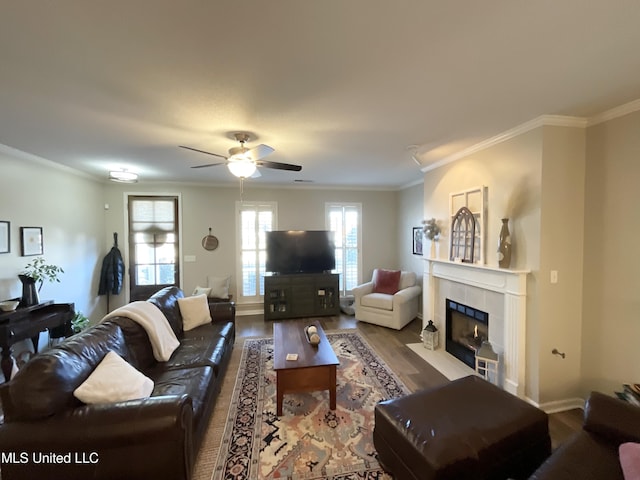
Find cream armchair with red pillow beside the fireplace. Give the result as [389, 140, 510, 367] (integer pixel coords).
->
[352, 269, 422, 330]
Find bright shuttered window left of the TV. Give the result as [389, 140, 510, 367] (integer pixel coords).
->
[236, 202, 276, 303]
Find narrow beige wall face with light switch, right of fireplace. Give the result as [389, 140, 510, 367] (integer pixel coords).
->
[536, 127, 586, 404]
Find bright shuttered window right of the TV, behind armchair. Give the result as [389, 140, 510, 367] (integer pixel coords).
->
[325, 203, 362, 295]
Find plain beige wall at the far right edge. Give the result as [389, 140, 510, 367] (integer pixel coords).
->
[582, 112, 640, 396]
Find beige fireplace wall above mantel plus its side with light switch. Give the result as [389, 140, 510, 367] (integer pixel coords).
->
[425, 126, 585, 404]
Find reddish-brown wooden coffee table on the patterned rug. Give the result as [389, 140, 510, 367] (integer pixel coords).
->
[273, 320, 340, 416]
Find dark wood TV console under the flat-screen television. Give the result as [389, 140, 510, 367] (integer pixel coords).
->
[264, 273, 340, 320]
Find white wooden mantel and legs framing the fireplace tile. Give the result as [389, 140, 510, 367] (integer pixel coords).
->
[423, 258, 529, 397]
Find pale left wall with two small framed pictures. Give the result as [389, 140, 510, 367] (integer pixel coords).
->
[0, 146, 105, 321]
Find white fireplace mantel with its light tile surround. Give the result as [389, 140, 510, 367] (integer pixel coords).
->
[423, 259, 528, 397]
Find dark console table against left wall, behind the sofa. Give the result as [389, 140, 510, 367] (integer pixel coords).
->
[0, 300, 75, 381]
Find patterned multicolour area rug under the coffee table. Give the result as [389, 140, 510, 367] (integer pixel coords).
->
[213, 330, 408, 480]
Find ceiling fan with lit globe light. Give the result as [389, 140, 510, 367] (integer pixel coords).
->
[180, 132, 302, 178]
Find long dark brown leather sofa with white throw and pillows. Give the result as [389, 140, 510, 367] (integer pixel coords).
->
[0, 287, 235, 480]
